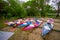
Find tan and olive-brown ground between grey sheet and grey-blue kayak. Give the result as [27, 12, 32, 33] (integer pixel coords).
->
[9, 28, 43, 40]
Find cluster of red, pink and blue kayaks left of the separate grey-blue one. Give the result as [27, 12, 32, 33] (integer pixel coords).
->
[5, 18, 43, 30]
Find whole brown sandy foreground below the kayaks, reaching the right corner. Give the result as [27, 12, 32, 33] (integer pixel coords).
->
[9, 28, 60, 40]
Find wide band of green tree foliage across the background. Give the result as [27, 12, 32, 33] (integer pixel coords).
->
[0, 0, 55, 18]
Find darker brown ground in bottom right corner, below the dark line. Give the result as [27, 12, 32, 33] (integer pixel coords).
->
[45, 31, 60, 40]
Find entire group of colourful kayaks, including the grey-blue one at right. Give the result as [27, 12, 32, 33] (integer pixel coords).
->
[5, 18, 54, 36]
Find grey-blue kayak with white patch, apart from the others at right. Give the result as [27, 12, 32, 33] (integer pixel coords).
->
[42, 23, 53, 36]
